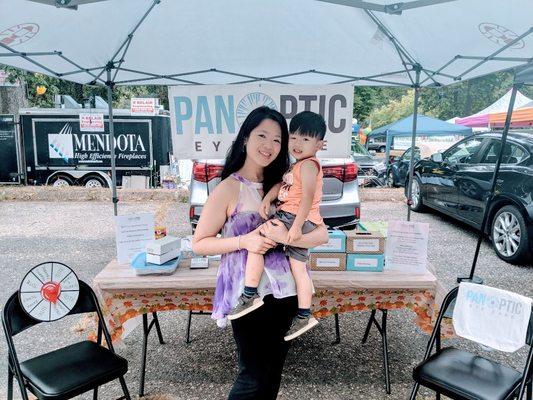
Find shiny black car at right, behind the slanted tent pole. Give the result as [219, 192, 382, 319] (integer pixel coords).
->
[411, 132, 533, 263]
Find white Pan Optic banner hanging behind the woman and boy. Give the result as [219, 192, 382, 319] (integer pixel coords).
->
[168, 85, 353, 159]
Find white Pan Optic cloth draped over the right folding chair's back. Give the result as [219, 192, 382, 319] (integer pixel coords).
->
[453, 282, 531, 352]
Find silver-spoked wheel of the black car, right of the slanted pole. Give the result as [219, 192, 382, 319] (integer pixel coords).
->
[491, 205, 529, 264]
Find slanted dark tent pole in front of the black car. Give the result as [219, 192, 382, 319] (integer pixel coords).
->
[457, 84, 521, 284]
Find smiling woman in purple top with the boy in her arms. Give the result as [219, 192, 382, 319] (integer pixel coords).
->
[193, 107, 328, 399]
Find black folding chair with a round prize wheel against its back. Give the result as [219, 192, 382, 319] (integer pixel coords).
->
[2, 281, 130, 400]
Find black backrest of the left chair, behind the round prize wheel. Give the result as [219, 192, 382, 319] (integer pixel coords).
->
[2, 281, 98, 336]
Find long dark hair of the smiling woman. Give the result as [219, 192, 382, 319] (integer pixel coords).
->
[222, 107, 289, 193]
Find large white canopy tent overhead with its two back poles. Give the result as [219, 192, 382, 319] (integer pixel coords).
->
[0, 0, 533, 219]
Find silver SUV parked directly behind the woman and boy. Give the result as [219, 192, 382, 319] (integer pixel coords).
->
[189, 158, 361, 231]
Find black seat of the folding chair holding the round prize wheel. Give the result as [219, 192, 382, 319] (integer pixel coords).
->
[20, 341, 128, 399]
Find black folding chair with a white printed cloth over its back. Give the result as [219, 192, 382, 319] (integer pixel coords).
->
[411, 287, 533, 400]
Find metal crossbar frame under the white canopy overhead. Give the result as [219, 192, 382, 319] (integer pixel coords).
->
[0, 0, 533, 88]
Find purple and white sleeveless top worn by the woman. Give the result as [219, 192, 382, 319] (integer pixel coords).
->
[211, 174, 296, 327]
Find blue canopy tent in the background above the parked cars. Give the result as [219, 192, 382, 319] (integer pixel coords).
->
[367, 114, 472, 166]
